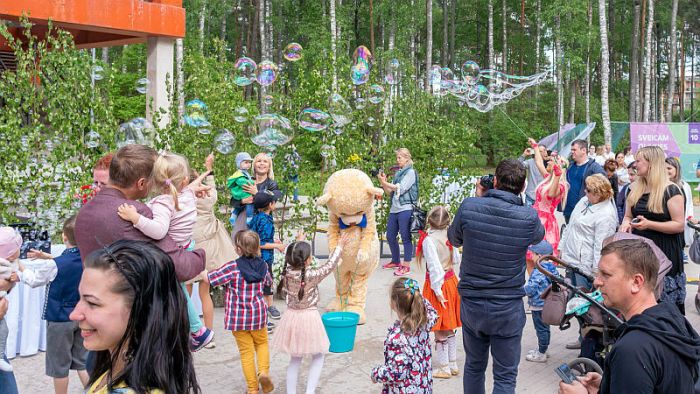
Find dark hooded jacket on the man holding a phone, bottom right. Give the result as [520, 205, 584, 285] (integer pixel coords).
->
[600, 303, 700, 394]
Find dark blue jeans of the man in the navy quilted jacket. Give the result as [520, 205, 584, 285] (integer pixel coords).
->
[460, 297, 526, 394]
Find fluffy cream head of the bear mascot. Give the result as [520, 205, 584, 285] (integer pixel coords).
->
[316, 168, 384, 225]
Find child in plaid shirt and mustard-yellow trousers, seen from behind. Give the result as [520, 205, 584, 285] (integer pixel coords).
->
[207, 230, 274, 394]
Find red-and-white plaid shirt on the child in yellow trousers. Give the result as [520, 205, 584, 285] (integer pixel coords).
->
[209, 261, 272, 331]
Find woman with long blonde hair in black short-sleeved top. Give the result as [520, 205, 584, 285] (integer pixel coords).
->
[620, 146, 685, 314]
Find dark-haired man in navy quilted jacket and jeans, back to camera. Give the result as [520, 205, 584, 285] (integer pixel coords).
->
[447, 159, 544, 394]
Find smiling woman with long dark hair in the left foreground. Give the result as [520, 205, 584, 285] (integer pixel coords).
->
[70, 240, 201, 394]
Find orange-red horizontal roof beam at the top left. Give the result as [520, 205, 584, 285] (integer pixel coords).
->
[0, 0, 185, 40]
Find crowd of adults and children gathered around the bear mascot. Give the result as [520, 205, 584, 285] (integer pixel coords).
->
[0, 139, 700, 394]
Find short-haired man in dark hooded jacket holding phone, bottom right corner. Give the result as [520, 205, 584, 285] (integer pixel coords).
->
[559, 239, 700, 394]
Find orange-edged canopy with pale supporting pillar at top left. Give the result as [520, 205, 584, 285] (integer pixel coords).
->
[0, 0, 185, 126]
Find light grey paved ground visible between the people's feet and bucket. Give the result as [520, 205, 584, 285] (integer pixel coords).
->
[12, 235, 700, 394]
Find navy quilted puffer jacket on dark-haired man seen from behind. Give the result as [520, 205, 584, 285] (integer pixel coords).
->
[447, 190, 544, 299]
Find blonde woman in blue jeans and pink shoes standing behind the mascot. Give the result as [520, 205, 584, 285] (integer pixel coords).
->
[377, 148, 418, 276]
